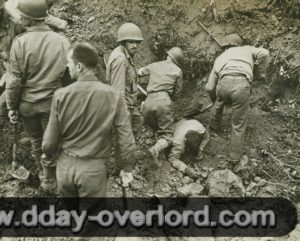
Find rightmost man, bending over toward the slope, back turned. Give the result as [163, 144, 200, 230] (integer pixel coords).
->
[206, 34, 269, 163]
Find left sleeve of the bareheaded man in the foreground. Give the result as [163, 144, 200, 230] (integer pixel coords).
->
[42, 92, 60, 157]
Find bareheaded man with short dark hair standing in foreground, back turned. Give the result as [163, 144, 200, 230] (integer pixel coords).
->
[43, 43, 135, 200]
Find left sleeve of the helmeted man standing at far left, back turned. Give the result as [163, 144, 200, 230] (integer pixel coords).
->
[6, 39, 23, 110]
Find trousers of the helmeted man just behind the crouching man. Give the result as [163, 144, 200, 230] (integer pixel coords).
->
[142, 92, 174, 144]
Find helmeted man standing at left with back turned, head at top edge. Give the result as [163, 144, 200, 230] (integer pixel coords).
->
[6, 0, 70, 190]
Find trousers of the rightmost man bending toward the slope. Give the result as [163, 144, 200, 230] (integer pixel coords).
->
[211, 75, 251, 159]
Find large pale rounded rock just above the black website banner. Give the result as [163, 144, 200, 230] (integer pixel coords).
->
[207, 169, 245, 197]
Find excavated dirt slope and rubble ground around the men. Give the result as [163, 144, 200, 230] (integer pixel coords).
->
[0, 0, 300, 241]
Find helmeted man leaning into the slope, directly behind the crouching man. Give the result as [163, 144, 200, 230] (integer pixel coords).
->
[138, 47, 184, 167]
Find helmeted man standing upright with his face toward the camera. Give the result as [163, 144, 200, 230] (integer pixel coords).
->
[106, 23, 143, 136]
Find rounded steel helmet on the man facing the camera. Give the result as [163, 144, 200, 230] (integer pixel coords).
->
[117, 23, 144, 42]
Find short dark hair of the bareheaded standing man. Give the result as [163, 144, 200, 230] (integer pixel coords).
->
[72, 42, 99, 68]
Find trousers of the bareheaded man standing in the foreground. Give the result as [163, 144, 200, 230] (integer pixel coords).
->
[56, 151, 106, 241]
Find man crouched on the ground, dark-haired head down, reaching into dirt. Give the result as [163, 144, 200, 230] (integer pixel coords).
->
[168, 119, 209, 178]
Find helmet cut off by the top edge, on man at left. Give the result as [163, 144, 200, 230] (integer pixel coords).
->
[17, 0, 48, 20]
